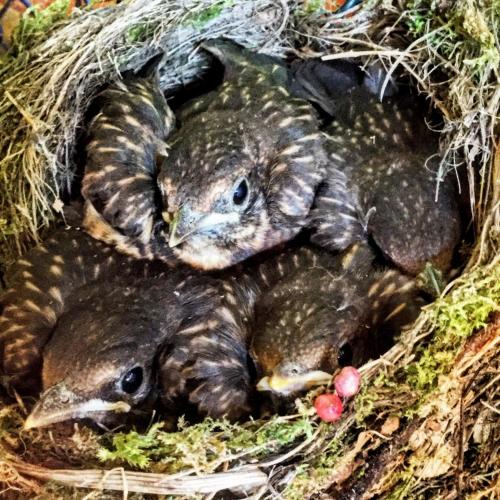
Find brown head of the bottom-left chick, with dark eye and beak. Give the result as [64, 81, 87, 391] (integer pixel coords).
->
[25, 284, 176, 429]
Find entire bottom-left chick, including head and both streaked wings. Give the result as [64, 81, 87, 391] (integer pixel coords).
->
[0, 214, 251, 427]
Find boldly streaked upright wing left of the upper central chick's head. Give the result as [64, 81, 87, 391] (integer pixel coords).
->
[82, 54, 175, 261]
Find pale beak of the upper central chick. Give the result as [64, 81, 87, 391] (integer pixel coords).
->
[168, 206, 239, 247]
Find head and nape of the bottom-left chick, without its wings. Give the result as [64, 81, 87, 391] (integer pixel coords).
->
[25, 270, 185, 429]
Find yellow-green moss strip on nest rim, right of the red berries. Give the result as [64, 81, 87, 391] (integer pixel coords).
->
[355, 264, 500, 424]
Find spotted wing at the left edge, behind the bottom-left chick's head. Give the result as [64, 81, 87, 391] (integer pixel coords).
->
[0, 223, 135, 389]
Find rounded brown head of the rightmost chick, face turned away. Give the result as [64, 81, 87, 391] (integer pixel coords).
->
[356, 151, 461, 274]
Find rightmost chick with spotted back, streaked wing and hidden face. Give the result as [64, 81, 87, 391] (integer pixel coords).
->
[310, 74, 461, 274]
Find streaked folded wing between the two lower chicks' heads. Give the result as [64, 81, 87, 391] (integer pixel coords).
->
[159, 281, 254, 420]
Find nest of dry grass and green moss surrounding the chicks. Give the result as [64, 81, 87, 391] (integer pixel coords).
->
[0, 0, 500, 499]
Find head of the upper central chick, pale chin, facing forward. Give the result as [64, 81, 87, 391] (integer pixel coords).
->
[159, 122, 270, 269]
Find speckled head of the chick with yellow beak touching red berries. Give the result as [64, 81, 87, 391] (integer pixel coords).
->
[252, 248, 369, 395]
